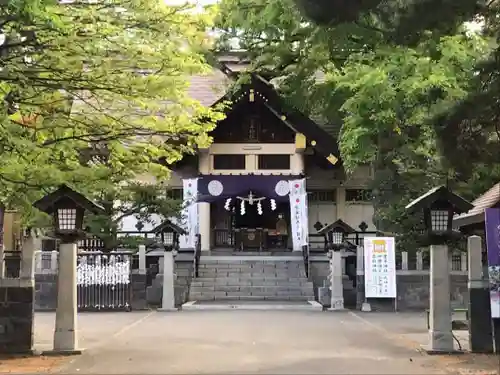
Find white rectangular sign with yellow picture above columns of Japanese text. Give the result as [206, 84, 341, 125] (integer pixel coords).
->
[363, 237, 397, 298]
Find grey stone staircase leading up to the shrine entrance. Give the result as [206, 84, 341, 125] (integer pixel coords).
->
[189, 256, 314, 302]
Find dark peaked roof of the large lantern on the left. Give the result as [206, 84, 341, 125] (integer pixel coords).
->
[33, 184, 104, 214]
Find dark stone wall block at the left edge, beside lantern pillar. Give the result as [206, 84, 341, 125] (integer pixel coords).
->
[0, 279, 34, 353]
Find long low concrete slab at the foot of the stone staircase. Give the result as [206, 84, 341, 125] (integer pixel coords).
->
[182, 301, 323, 311]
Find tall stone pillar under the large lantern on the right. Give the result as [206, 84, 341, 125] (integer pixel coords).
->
[427, 245, 454, 353]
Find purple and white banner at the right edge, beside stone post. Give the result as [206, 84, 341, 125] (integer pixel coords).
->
[484, 208, 500, 318]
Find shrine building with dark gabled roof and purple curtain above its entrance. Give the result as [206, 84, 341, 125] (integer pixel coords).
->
[124, 55, 375, 251]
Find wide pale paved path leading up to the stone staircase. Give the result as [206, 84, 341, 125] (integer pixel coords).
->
[32, 311, 492, 374]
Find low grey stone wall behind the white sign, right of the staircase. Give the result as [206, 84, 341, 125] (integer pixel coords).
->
[310, 256, 469, 311]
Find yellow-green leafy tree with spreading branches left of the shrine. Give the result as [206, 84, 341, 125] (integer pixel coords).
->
[0, 0, 221, 238]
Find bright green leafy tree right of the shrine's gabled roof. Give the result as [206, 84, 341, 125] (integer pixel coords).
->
[218, 0, 500, 247]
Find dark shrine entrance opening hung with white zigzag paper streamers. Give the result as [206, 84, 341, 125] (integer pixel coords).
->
[211, 191, 290, 251]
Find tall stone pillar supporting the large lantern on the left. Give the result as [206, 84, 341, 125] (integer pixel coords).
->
[54, 243, 81, 354]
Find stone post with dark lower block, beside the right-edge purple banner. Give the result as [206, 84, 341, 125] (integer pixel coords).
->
[467, 236, 493, 353]
